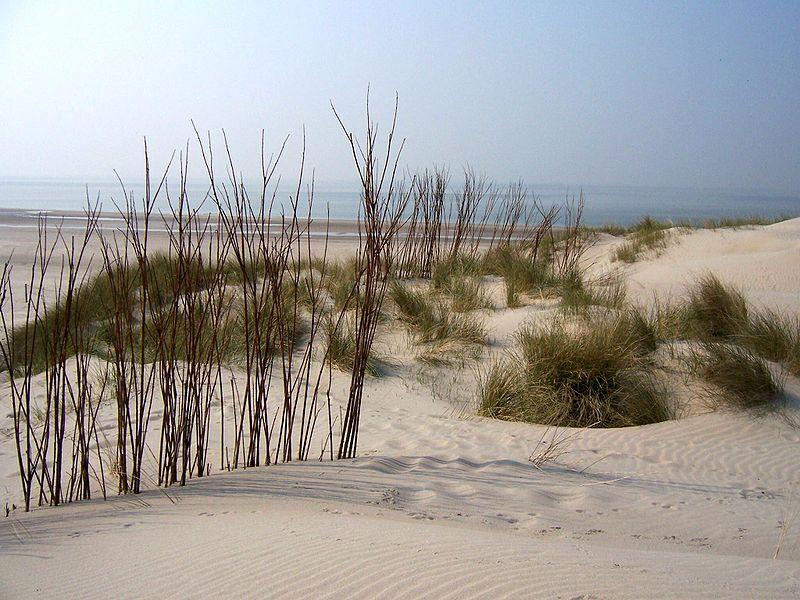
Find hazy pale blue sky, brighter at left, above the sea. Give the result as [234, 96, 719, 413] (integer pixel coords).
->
[0, 0, 800, 193]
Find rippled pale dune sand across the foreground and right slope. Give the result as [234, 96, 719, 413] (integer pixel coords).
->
[0, 219, 800, 599]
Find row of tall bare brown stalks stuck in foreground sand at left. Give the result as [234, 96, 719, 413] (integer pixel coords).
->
[0, 96, 406, 510]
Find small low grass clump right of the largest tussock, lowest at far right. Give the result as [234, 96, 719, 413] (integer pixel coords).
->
[689, 343, 783, 409]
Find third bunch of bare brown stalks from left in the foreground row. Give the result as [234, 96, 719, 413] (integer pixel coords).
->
[150, 151, 230, 485]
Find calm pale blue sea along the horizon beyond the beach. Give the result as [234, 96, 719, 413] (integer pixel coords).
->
[0, 178, 800, 225]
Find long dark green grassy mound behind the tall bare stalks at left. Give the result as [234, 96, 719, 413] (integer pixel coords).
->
[3, 253, 322, 373]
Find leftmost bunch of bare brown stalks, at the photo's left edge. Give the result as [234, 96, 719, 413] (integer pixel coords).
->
[0, 205, 102, 510]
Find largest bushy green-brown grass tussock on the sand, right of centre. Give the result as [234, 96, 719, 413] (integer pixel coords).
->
[478, 317, 673, 427]
